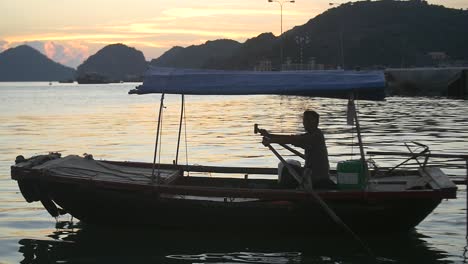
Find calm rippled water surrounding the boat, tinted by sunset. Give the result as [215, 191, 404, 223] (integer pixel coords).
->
[0, 83, 468, 263]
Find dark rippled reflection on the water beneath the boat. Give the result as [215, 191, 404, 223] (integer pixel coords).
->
[19, 222, 449, 264]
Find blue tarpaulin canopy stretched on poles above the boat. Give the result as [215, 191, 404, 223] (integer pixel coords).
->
[130, 67, 385, 100]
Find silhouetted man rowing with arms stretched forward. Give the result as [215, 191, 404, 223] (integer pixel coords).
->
[260, 110, 335, 189]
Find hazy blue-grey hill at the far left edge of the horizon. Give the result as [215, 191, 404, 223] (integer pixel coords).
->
[0, 45, 75, 82]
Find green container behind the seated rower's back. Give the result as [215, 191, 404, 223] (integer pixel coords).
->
[336, 160, 367, 190]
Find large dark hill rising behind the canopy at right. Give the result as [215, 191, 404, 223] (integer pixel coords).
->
[157, 0, 468, 70]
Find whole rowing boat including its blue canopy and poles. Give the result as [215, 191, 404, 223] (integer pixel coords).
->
[11, 68, 457, 233]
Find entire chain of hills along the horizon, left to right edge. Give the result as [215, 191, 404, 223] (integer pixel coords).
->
[0, 0, 468, 82]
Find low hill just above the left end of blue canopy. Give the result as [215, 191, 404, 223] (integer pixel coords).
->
[151, 39, 241, 68]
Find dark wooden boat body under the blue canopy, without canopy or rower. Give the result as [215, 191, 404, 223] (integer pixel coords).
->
[11, 67, 457, 232]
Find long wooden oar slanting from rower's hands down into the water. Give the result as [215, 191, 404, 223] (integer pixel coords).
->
[254, 124, 375, 259]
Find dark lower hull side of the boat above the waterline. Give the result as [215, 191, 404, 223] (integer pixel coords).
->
[19, 177, 441, 233]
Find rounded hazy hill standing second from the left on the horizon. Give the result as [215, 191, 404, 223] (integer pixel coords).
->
[77, 44, 148, 81]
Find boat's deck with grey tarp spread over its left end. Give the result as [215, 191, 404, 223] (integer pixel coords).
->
[12, 155, 455, 192]
